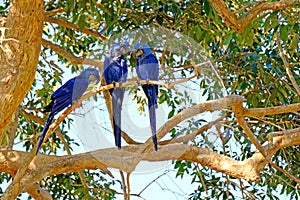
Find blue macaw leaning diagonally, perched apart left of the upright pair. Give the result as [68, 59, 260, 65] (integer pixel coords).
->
[36, 68, 100, 155]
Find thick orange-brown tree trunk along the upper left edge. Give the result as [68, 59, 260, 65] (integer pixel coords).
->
[0, 0, 44, 139]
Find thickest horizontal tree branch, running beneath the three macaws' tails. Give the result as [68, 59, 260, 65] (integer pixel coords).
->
[0, 126, 300, 197]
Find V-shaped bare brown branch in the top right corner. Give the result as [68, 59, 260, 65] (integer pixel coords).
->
[210, 0, 299, 33]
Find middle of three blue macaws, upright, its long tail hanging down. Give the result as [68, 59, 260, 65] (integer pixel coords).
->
[104, 42, 130, 149]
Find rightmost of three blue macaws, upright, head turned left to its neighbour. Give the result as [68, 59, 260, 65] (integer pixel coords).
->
[134, 43, 159, 151]
